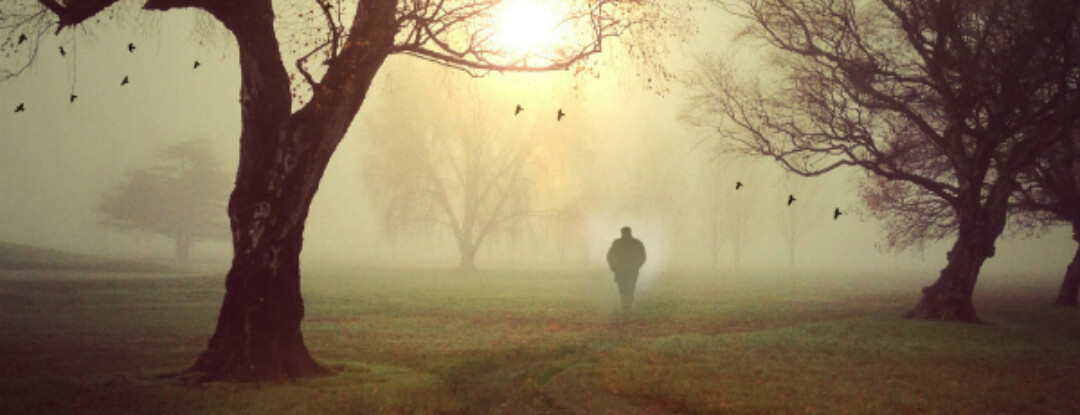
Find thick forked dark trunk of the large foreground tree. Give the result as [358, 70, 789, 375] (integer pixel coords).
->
[191, 1, 396, 380]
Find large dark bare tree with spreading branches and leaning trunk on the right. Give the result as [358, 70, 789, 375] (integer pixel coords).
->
[692, 0, 1080, 322]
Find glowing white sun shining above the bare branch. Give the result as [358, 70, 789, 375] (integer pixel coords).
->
[496, 0, 559, 54]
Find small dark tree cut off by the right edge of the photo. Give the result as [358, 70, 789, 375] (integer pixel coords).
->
[1014, 128, 1080, 307]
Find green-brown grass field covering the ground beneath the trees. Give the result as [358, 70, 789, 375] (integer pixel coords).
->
[0, 269, 1080, 414]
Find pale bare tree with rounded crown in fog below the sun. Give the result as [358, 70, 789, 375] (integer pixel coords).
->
[362, 79, 572, 271]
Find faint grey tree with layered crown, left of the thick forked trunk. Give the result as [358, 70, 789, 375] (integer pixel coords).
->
[97, 139, 231, 259]
